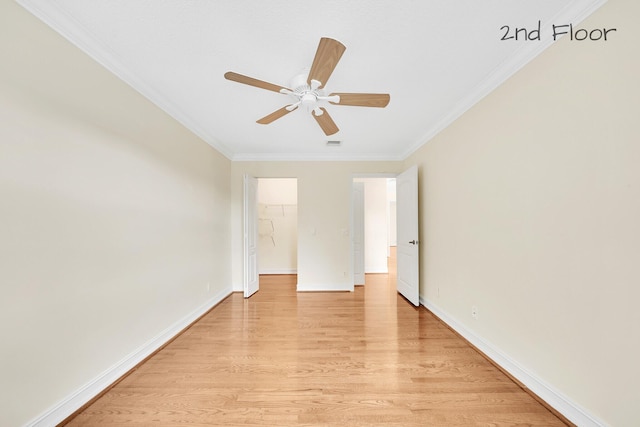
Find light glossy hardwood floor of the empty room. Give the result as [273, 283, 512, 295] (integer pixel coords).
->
[68, 252, 565, 427]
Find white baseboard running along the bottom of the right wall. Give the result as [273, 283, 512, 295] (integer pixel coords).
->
[420, 297, 607, 427]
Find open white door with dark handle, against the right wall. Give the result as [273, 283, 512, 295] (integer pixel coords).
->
[396, 166, 420, 306]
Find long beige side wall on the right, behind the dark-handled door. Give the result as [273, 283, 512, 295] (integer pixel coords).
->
[405, 0, 640, 426]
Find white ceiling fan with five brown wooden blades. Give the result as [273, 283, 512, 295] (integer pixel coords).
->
[224, 37, 390, 135]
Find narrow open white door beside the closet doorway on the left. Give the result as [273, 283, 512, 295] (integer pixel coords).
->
[243, 175, 260, 298]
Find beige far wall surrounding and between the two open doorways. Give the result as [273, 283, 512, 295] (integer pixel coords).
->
[231, 162, 401, 291]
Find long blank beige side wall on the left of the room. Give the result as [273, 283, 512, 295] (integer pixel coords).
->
[0, 2, 231, 426]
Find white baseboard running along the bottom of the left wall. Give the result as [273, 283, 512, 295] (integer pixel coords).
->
[26, 288, 231, 427]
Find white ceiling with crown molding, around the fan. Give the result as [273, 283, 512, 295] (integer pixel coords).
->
[18, 0, 604, 160]
